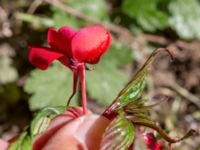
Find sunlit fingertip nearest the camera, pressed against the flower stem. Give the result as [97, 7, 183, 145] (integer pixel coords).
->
[38, 114, 109, 150]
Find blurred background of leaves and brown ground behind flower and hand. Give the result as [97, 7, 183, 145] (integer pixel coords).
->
[0, 0, 200, 150]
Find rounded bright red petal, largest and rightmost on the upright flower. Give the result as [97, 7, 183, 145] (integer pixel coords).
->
[71, 25, 111, 64]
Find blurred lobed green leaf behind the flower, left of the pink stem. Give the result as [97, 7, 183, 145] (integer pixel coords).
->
[25, 62, 77, 110]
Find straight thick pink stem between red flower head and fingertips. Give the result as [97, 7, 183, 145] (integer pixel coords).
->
[79, 63, 87, 114]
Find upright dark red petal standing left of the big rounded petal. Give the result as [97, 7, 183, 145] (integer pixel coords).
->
[48, 26, 76, 57]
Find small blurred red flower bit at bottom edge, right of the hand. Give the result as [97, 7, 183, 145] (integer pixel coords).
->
[144, 132, 162, 150]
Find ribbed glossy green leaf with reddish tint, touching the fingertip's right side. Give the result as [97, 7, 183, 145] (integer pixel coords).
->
[100, 114, 135, 150]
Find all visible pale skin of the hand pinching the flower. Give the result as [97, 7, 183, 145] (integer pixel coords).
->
[0, 108, 110, 150]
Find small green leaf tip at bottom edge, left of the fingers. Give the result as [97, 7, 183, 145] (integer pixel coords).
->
[8, 132, 32, 150]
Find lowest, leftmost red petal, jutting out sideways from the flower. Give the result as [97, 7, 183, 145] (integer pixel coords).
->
[29, 47, 63, 70]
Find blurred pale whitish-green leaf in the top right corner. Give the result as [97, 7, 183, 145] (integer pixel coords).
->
[169, 0, 200, 39]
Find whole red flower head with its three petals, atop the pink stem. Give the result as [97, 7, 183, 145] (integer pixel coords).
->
[29, 25, 111, 70]
